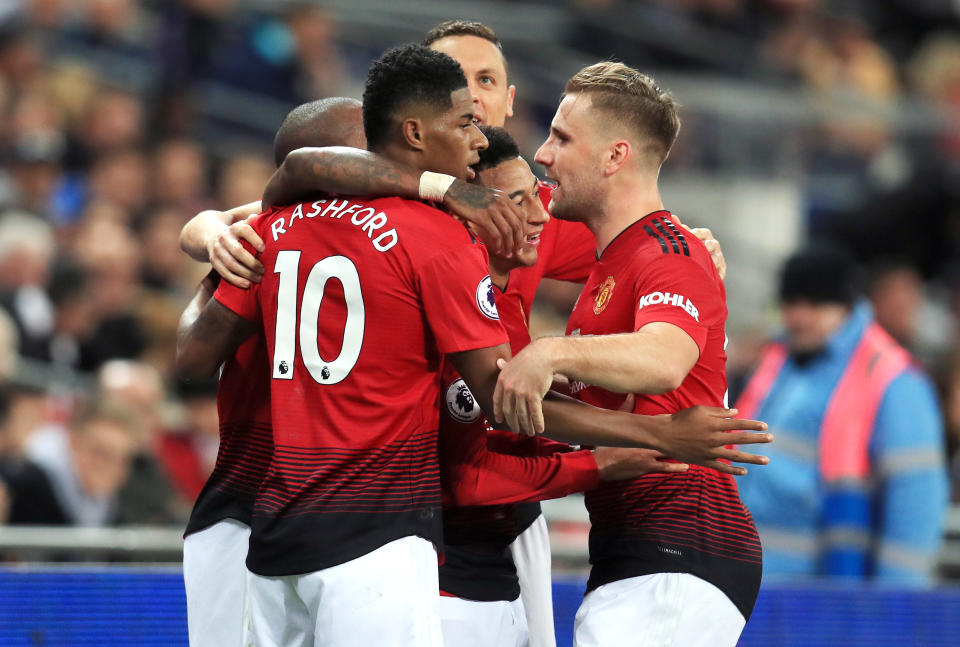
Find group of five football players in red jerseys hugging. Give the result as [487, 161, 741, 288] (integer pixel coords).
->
[177, 21, 772, 647]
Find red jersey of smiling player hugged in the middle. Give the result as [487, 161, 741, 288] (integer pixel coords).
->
[439, 287, 600, 601]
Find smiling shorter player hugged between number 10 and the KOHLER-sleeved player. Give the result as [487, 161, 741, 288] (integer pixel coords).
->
[439, 127, 686, 647]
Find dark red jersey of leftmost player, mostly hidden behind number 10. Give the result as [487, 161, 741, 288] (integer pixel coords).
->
[185, 334, 273, 535]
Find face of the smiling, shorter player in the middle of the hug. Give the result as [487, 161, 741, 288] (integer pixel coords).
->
[480, 157, 550, 270]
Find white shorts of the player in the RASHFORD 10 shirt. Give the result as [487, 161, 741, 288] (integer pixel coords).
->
[243, 536, 443, 647]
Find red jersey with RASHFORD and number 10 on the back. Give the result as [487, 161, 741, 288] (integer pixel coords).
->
[215, 198, 507, 575]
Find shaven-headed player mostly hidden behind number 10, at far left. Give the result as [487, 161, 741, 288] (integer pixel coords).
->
[180, 98, 366, 647]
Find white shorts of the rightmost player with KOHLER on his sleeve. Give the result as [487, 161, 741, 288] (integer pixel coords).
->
[573, 573, 746, 647]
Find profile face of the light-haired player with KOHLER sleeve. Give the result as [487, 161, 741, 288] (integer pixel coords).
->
[534, 94, 602, 221]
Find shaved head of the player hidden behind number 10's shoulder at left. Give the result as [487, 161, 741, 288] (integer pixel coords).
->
[273, 97, 360, 166]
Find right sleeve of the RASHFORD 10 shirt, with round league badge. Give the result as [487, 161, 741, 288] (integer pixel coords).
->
[420, 245, 507, 354]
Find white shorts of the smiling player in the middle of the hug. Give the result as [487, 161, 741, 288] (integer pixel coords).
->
[440, 596, 530, 647]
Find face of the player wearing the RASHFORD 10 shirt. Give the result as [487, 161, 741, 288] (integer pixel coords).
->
[423, 88, 487, 180]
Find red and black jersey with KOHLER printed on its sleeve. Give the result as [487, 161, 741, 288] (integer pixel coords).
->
[567, 211, 761, 615]
